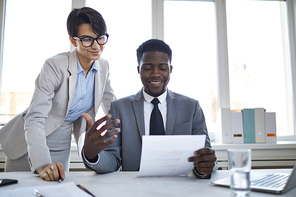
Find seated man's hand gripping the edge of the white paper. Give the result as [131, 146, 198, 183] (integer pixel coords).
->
[188, 148, 217, 175]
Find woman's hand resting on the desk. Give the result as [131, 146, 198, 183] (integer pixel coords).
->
[38, 162, 65, 181]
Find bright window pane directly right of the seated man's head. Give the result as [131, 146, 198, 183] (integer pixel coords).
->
[164, 1, 218, 139]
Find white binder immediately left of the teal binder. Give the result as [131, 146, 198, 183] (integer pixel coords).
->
[231, 110, 244, 144]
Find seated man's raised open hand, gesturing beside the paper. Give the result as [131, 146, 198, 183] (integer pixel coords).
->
[82, 113, 120, 161]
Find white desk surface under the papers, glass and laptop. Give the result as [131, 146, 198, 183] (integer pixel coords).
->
[0, 169, 296, 197]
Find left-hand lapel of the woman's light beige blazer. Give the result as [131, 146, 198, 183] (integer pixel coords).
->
[66, 48, 77, 114]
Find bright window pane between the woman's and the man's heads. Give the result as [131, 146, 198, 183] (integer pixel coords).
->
[86, 0, 151, 98]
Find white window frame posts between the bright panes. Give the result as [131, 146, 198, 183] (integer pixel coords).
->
[0, 0, 296, 143]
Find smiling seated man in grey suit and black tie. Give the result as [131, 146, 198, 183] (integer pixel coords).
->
[82, 39, 217, 178]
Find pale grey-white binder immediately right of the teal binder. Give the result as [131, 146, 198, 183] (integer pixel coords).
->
[254, 108, 266, 143]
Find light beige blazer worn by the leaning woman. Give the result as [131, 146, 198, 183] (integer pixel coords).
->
[0, 49, 115, 171]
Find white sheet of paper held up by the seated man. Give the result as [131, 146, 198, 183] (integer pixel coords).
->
[138, 135, 206, 177]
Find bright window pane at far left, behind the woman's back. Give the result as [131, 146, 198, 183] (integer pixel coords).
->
[0, 0, 71, 123]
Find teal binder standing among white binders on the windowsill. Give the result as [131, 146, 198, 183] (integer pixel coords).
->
[242, 109, 256, 143]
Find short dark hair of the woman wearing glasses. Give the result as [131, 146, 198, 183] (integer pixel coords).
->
[67, 7, 107, 37]
